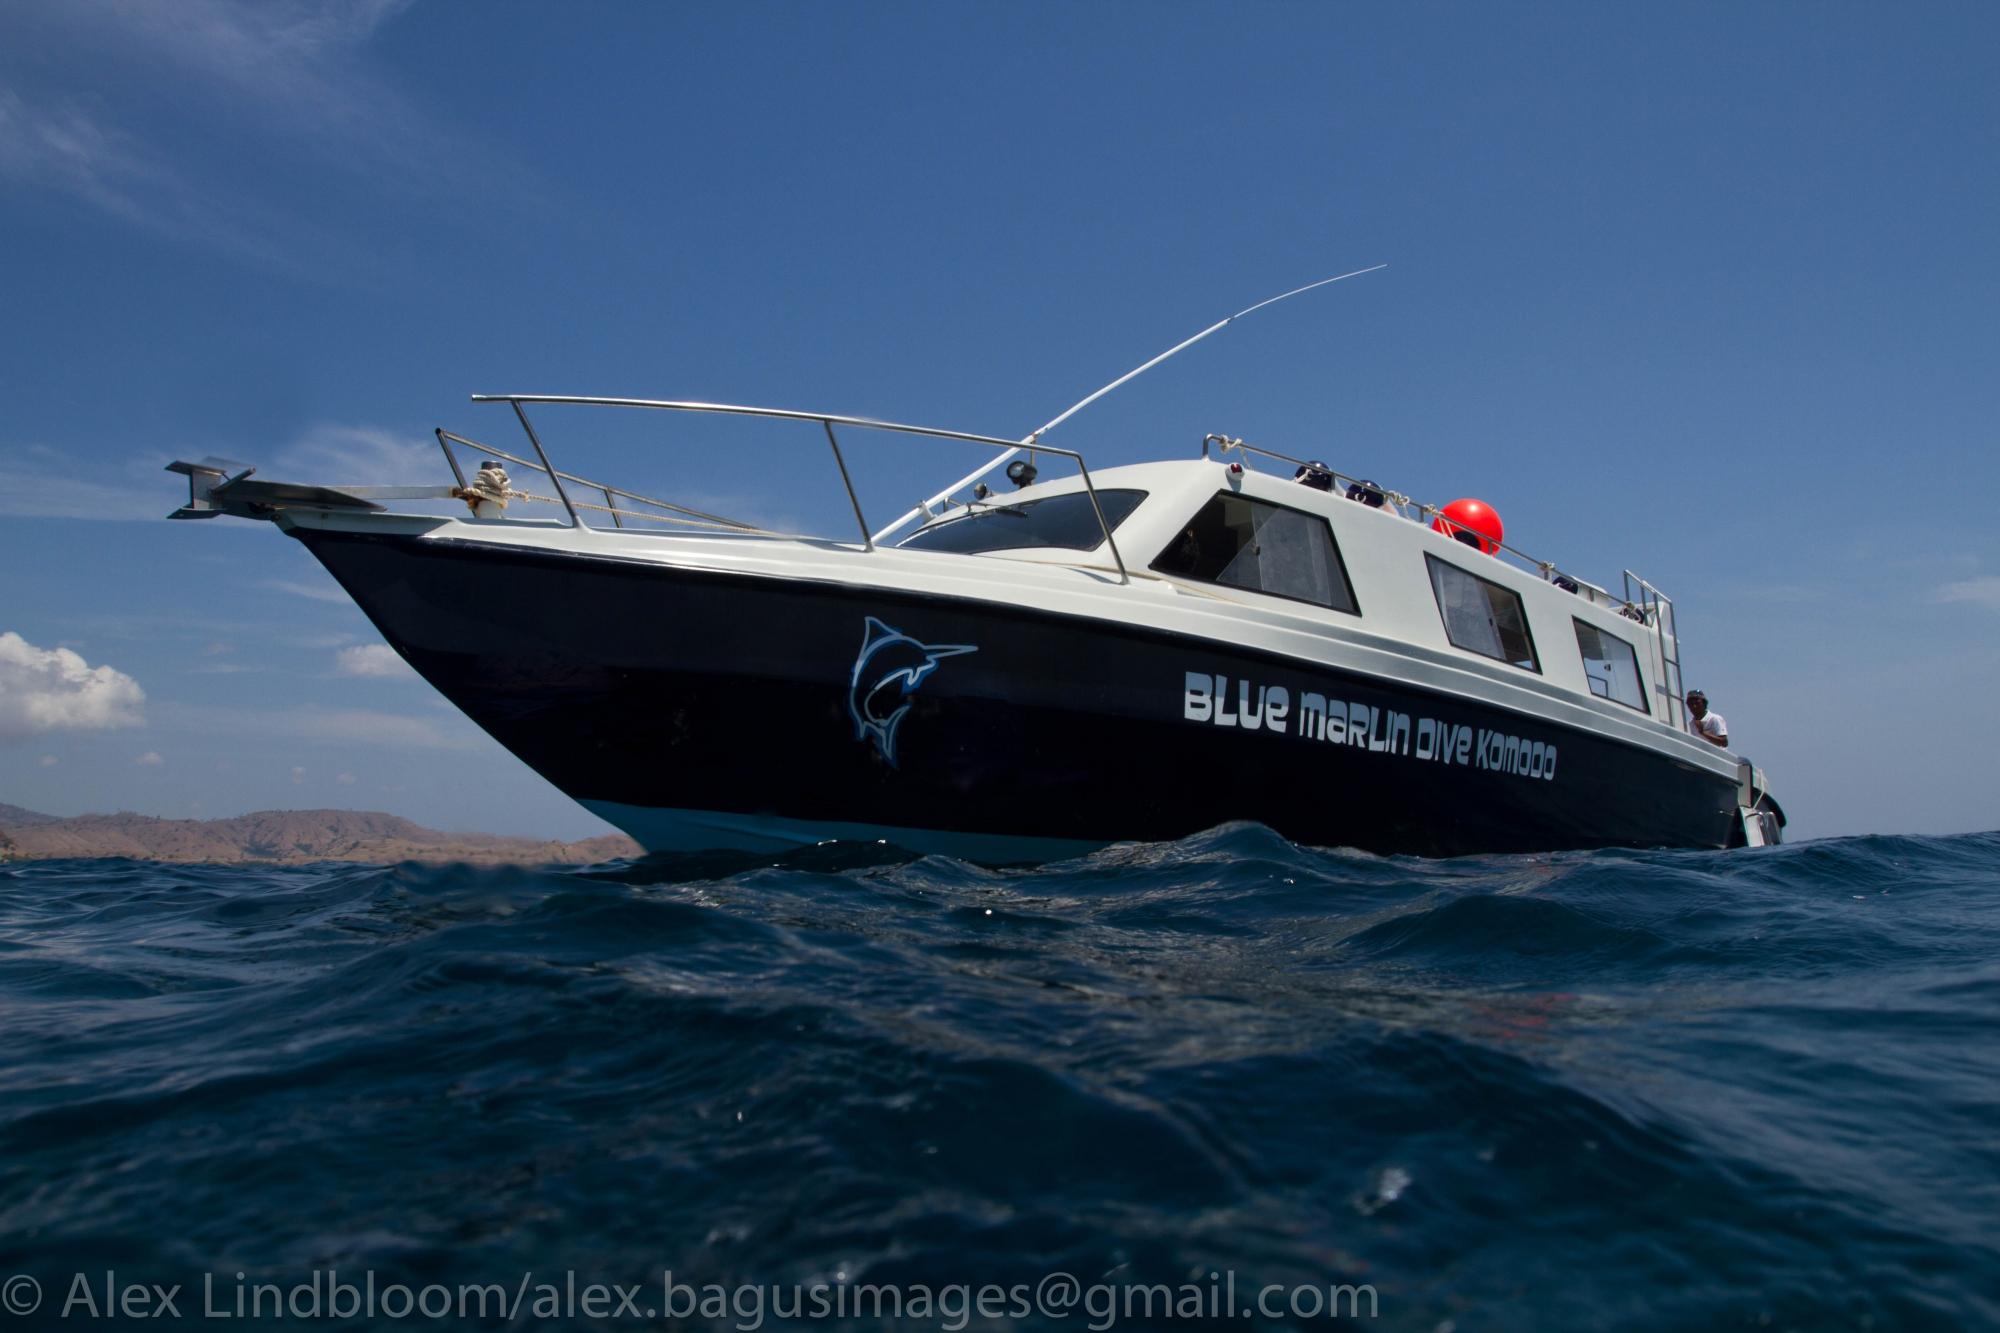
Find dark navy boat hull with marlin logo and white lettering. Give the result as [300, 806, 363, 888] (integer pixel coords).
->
[294, 526, 1740, 861]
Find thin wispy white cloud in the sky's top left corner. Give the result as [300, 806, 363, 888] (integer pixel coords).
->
[0, 0, 476, 278]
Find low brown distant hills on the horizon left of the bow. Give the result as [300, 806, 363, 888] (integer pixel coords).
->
[0, 805, 640, 865]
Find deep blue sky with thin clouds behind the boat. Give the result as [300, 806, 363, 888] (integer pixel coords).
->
[0, 0, 2000, 837]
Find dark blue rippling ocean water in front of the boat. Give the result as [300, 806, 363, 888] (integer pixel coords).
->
[0, 825, 2000, 1331]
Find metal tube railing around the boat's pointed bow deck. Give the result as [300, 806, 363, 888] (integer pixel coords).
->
[458, 394, 1132, 582]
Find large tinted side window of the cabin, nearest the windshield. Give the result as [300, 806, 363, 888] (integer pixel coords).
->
[1152, 492, 1360, 614]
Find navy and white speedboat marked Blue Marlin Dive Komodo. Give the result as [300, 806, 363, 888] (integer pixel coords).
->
[160, 390, 1784, 863]
